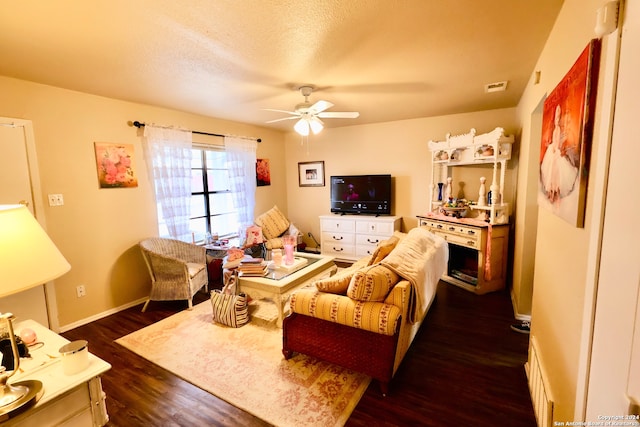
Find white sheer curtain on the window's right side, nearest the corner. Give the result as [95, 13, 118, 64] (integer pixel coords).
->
[224, 136, 258, 240]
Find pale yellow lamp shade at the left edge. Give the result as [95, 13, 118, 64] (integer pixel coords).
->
[0, 205, 71, 298]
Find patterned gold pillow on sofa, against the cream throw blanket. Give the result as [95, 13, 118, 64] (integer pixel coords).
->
[347, 264, 400, 301]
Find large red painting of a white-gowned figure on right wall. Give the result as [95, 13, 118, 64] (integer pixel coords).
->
[538, 39, 600, 227]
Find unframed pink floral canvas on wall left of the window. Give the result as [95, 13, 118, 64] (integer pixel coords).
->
[95, 142, 138, 188]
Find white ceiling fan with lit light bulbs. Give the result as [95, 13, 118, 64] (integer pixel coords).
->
[266, 85, 360, 136]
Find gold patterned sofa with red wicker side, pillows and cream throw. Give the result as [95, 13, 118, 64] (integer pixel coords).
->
[282, 227, 449, 395]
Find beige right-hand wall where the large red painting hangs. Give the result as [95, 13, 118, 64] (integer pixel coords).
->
[515, 0, 615, 422]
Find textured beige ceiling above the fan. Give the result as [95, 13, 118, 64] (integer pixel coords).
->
[0, 0, 562, 129]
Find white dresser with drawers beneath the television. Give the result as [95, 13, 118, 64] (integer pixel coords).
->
[320, 215, 402, 261]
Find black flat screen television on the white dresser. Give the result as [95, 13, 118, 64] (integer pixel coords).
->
[331, 175, 392, 215]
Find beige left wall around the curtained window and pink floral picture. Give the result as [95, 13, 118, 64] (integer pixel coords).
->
[0, 77, 287, 329]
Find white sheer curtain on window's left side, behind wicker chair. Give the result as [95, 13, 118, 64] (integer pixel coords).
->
[143, 125, 192, 242]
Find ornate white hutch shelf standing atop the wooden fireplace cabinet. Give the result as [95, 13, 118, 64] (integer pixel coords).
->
[429, 127, 514, 224]
